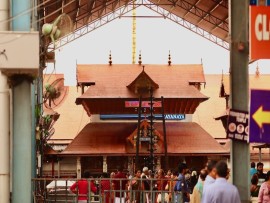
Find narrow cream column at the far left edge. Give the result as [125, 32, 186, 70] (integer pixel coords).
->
[0, 0, 10, 202]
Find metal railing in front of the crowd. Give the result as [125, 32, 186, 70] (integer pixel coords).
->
[32, 178, 183, 203]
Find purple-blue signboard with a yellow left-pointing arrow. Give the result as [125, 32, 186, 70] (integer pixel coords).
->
[249, 90, 270, 143]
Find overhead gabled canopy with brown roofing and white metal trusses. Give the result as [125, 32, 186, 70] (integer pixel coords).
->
[39, 0, 229, 49]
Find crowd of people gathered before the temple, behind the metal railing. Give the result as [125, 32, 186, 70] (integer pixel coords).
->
[70, 160, 243, 203]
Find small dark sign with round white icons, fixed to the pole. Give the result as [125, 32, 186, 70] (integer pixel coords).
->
[227, 110, 249, 141]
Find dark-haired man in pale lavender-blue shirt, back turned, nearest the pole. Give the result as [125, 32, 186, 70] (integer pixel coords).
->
[204, 161, 241, 203]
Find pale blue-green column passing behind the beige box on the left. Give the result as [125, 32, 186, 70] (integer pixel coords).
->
[10, 0, 35, 203]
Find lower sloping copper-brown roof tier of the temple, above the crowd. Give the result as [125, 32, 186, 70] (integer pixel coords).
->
[61, 122, 229, 156]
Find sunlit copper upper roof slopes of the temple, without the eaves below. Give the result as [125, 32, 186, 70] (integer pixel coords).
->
[77, 64, 207, 99]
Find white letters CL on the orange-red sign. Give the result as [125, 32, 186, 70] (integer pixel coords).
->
[255, 14, 270, 41]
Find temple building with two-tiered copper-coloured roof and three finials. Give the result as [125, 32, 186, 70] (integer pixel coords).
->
[44, 56, 229, 177]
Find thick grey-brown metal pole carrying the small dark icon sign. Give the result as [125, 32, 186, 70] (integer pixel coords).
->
[229, 0, 250, 202]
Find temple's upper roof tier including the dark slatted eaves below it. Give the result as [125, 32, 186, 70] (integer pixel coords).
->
[76, 64, 208, 116]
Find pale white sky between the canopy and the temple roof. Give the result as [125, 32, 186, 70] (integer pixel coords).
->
[44, 7, 270, 86]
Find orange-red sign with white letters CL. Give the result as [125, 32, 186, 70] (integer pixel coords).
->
[249, 6, 270, 60]
